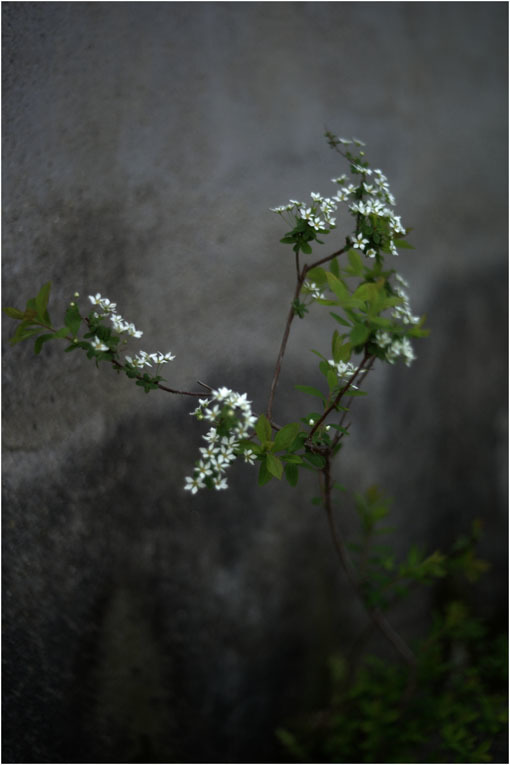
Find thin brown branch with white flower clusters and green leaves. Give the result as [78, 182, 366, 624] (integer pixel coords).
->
[4, 133, 427, 680]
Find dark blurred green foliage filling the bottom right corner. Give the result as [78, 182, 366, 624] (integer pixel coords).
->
[277, 560, 508, 763]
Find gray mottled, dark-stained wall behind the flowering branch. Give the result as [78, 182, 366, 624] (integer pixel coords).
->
[2, 2, 508, 762]
